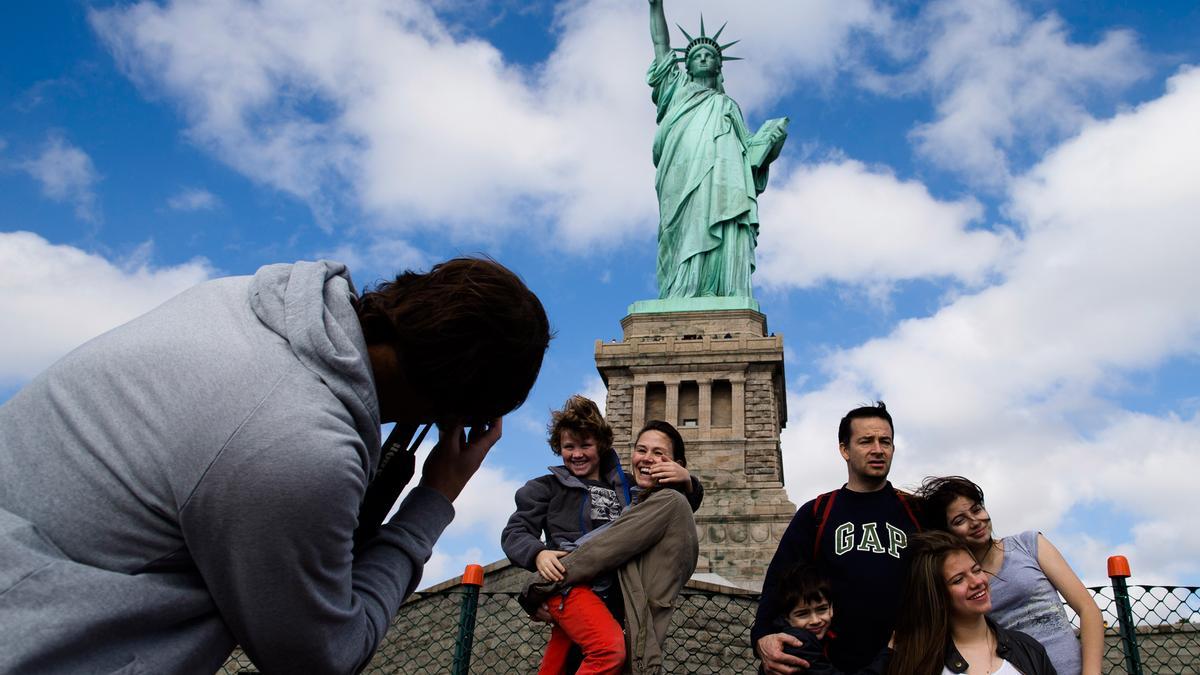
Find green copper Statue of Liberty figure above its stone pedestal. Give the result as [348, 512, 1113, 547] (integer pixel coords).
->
[647, 0, 787, 299]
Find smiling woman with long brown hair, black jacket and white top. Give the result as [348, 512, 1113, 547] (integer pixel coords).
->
[887, 532, 1057, 675]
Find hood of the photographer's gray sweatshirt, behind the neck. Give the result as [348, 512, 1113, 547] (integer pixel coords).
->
[242, 261, 379, 458]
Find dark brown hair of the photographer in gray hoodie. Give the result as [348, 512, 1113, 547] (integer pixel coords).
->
[356, 258, 551, 422]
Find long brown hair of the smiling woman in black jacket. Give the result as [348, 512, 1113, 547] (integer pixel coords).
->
[887, 531, 974, 675]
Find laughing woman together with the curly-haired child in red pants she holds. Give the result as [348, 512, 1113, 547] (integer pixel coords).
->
[502, 396, 703, 674]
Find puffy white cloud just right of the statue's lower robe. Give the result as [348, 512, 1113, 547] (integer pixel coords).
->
[755, 160, 1013, 287]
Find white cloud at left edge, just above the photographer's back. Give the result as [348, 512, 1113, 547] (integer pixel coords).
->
[0, 232, 211, 382]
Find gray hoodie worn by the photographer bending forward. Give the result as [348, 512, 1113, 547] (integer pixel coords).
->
[0, 262, 454, 675]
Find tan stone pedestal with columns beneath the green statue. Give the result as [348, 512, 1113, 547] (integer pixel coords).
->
[595, 309, 796, 590]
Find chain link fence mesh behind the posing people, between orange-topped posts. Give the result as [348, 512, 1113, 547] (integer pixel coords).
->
[221, 578, 1200, 675]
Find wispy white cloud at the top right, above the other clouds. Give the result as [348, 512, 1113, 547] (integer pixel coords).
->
[910, 0, 1146, 187]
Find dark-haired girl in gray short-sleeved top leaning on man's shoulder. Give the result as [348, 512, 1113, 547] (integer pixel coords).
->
[917, 476, 1104, 675]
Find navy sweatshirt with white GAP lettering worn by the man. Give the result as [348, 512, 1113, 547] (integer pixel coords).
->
[750, 483, 918, 671]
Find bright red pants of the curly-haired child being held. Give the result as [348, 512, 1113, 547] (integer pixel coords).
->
[538, 586, 625, 675]
